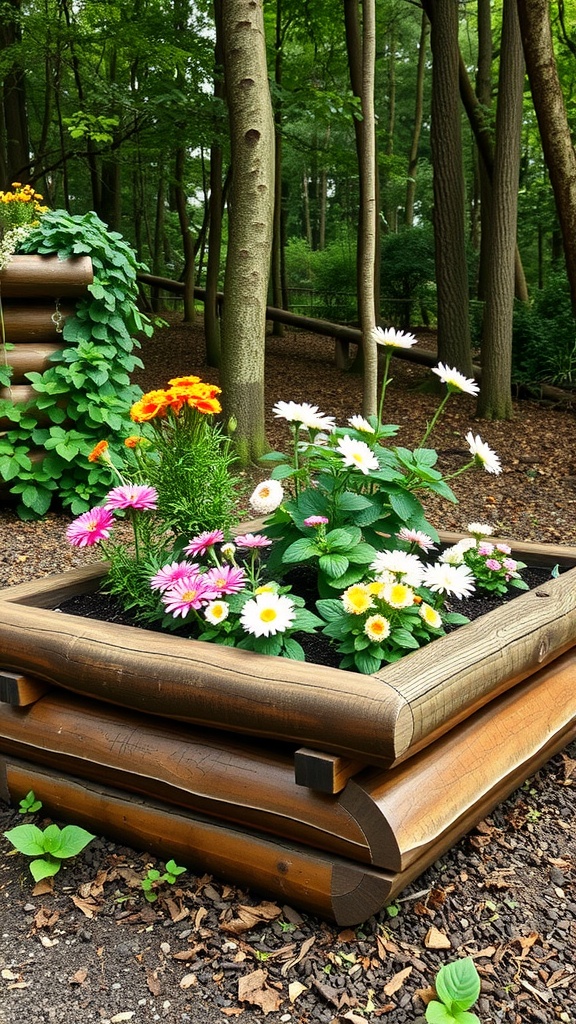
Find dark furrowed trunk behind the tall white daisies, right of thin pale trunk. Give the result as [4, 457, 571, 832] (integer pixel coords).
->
[426, 0, 472, 377]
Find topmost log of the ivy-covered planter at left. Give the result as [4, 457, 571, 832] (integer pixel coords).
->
[0, 256, 93, 299]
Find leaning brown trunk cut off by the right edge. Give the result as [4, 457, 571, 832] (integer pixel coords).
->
[518, 0, 576, 315]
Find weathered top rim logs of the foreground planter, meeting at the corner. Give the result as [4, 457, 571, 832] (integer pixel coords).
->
[0, 567, 576, 767]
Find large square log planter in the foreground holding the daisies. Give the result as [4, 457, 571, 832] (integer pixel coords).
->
[0, 539, 576, 925]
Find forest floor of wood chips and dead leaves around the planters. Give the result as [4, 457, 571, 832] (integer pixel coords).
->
[0, 318, 576, 1024]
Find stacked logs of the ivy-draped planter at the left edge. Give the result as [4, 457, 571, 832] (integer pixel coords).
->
[0, 256, 93, 430]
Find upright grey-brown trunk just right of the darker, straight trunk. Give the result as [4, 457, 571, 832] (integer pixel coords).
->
[478, 0, 524, 420]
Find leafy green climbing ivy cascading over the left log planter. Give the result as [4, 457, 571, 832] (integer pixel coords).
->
[0, 210, 153, 519]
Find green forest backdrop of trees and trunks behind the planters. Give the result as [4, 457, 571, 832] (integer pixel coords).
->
[0, 0, 576, 460]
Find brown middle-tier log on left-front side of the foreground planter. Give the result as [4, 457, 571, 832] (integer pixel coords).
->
[0, 690, 370, 863]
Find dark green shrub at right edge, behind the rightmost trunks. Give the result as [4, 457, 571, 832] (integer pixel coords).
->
[512, 274, 576, 386]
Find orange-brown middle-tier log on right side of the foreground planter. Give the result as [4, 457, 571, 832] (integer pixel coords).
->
[340, 650, 576, 873]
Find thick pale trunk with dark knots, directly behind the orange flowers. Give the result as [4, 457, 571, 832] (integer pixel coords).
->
[221, 0, 274, 465]
